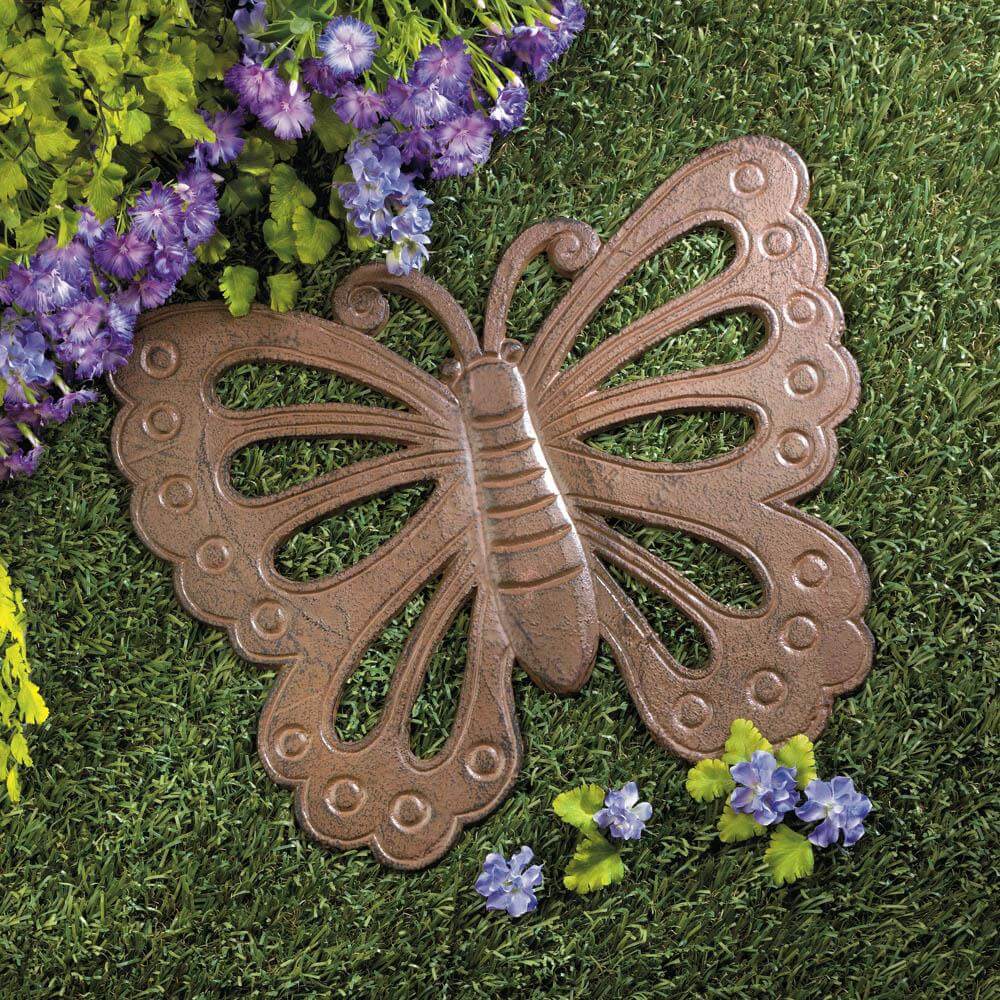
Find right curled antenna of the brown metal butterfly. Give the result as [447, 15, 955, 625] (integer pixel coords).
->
[483, 219, 601, 351]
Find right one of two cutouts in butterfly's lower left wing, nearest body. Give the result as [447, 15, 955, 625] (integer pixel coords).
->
[410, 592, 476, 758]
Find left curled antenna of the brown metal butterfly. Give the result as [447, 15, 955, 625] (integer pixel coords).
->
[333, 264, 483, 361]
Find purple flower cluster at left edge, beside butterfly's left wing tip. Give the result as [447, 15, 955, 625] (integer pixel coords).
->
[0, 121, 243, 482]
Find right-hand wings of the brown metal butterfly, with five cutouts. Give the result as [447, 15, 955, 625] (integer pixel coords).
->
[525, 137, 872, 757]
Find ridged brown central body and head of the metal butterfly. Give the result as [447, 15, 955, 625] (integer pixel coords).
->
[450, 341, 599, 693]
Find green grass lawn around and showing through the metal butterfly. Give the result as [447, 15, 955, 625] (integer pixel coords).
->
[0, 0, 1000, 1000]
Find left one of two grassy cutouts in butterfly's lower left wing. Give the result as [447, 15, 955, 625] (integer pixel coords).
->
[333, 577, 440, 743]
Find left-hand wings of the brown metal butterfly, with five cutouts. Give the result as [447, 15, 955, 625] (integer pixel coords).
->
[113, 298, 520, 867]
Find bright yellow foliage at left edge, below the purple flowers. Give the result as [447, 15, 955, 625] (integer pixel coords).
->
[0, 559, 49, 802]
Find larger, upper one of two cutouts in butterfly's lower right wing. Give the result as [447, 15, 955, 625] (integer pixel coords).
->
[607, 518, 765, 611]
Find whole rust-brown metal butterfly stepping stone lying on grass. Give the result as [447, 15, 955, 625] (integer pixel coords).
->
[113, 137, 872, 868]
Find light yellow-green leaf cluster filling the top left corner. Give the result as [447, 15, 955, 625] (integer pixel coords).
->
[0, 0, 237, 260]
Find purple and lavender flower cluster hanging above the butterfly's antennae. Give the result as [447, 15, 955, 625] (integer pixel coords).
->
[226, 6, 586, 274]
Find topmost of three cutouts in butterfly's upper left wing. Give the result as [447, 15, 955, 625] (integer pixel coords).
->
[215, 360, 407, 410]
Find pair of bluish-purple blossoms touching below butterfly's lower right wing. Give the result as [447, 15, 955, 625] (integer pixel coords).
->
[729, 750, 872, 847]
